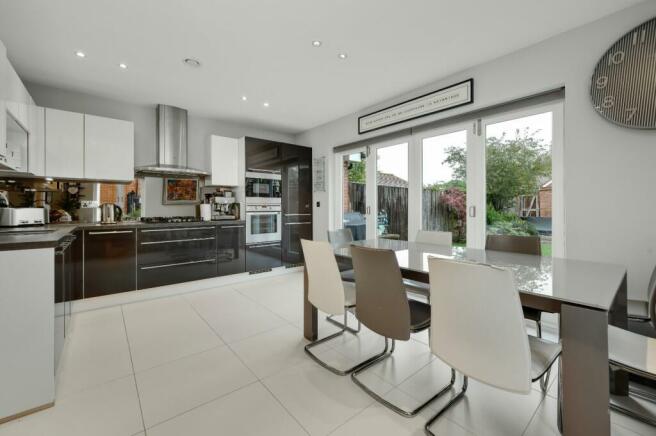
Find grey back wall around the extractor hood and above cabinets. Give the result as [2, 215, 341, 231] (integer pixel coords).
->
[26, 82, 294, 216]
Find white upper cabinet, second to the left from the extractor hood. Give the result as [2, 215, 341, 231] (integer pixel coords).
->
[45, 108, 84, 179]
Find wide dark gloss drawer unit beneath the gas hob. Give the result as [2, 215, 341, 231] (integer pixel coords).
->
[137, 226, 217, 289]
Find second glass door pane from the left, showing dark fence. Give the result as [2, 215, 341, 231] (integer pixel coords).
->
[370, 142, 408, 241]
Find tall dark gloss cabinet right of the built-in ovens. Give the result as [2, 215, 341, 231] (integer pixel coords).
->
[281, 144, 312, 266]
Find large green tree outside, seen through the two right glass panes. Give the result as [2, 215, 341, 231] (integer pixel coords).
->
[444, 129, 551, 210]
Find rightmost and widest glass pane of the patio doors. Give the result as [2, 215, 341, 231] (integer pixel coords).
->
[485, 111, 553, 256]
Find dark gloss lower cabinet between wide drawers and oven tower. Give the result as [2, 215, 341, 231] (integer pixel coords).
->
[216, 224, 246, 276]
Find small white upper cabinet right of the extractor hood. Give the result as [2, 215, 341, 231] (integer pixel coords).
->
[209, 135, 244, 186]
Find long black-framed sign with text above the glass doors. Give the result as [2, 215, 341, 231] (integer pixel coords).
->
[358, 79, 474, 135]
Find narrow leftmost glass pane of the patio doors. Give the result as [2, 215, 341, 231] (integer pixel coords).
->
[340, 150, 367, 241]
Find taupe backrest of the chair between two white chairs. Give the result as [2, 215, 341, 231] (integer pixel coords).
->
[351, 246, 410, 341]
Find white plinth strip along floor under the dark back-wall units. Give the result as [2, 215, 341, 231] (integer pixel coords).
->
[72, 267, 303, 313]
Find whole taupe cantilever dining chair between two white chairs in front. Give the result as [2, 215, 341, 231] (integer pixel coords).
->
[351, 246, 455, 417]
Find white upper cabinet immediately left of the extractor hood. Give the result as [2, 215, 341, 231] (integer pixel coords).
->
[84, 115, 134, 181]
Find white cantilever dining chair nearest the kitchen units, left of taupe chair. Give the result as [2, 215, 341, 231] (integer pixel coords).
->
[301, 239, 382, 375]
